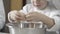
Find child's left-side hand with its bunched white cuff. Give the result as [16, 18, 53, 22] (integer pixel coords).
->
[8, 10, 25, 21]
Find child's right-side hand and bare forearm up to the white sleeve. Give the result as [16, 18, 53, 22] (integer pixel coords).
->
[26, 12, 54, 28]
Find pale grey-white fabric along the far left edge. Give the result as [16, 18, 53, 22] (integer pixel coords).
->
[0, 0, 5, 29]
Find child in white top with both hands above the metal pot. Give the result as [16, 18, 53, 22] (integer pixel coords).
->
[8, 0, 60, 31]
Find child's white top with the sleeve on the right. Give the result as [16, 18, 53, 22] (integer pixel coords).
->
[20, 4, 60, 31]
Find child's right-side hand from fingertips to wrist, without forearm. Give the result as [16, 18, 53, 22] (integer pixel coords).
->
[26, 12, 43, 21]
